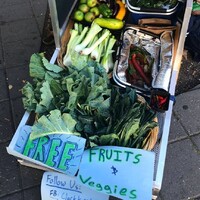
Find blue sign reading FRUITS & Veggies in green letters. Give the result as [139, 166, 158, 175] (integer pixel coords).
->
[78, 147, 155, 200]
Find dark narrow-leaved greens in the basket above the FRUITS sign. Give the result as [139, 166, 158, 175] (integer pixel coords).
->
[89, 87, 158, 148]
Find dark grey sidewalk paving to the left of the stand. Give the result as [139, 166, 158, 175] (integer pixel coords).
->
[0, 0, 47, 200]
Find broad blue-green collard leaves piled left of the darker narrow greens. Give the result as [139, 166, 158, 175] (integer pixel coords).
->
[22, 54, 110, 117]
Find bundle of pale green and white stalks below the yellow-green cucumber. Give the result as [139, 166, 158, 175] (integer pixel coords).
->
[63, 22, 116, 72]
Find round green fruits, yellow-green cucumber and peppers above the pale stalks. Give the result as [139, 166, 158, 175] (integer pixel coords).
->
[73, 0, 126, 30]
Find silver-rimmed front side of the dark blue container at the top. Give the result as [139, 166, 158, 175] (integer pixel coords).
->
[126, 0, 180, 24]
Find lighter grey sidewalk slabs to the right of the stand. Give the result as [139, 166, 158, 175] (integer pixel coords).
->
[159, 88, 200, 200]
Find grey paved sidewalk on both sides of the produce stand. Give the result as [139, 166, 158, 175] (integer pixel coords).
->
[0, 0, 200, 200]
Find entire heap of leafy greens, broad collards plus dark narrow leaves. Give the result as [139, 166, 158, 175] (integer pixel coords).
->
[22, 54, 158, 148]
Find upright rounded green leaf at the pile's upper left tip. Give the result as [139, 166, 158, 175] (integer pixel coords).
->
[29, 53, 45, 79]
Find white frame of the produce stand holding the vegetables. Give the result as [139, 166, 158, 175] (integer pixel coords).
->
[7, 0, 192, 199]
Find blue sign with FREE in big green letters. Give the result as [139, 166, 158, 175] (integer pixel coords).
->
[14, 125, 86, 176]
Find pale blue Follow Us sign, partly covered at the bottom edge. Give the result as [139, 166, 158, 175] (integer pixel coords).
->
[41, 172, 109, 200]
